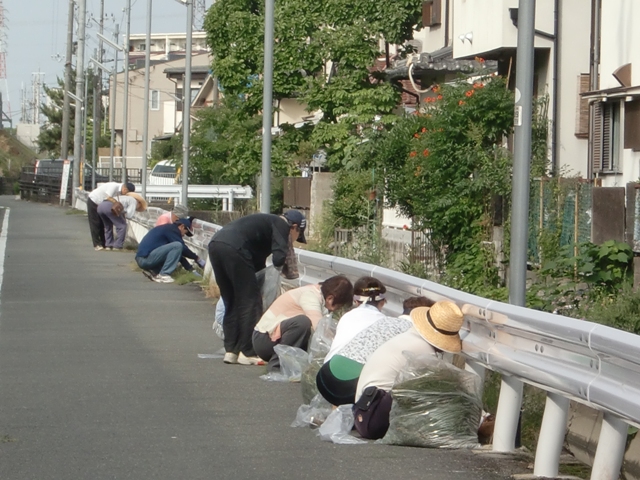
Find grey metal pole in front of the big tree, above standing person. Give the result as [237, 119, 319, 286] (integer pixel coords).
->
[260, 0, 275, 213]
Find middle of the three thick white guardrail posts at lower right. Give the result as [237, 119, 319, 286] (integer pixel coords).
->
[533, 392, 569, 478]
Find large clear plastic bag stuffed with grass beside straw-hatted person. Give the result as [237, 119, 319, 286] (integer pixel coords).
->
[378, 355, 482, 448]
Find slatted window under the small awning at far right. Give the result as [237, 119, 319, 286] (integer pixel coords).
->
[593, 101, 620, 173]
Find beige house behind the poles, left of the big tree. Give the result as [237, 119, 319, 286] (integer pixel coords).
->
[109, 53, 211, 168]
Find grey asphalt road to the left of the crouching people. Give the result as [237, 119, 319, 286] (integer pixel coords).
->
[0, 196, 526, 480]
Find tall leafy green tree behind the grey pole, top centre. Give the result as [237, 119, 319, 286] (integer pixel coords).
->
[205, 0, 422, 169]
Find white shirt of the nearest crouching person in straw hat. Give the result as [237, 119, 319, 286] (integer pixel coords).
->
[355, 322, 436, 401]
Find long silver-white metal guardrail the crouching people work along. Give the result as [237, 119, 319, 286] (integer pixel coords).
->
[74, 189, 640, 480]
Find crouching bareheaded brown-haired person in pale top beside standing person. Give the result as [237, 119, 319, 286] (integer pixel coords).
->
[253, 275, 353, 371]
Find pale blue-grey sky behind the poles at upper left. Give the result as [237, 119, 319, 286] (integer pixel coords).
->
[5, 0, 211, 125]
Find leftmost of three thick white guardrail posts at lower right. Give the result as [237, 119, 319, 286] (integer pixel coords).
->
[493, 375, 522, 452]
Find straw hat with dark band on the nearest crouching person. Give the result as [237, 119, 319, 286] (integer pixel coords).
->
[411, 300, 464, 353]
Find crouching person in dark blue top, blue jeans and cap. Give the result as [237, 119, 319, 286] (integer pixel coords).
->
[136, 218, 205, 283]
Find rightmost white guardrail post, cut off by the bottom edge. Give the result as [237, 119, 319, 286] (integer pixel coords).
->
[591, 412, 628, 480]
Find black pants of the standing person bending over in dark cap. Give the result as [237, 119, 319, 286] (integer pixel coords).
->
[209, 242, 262, 357]
